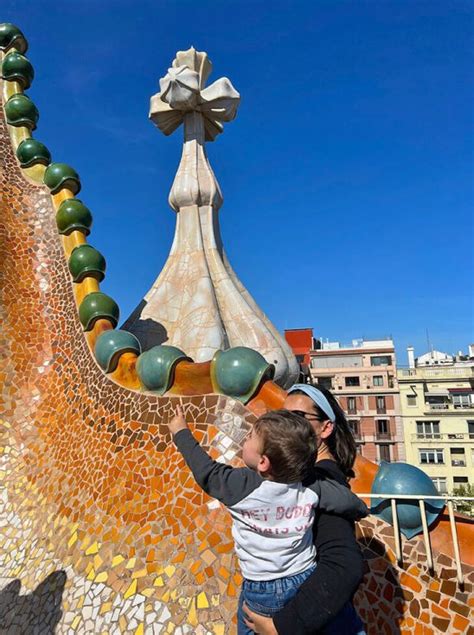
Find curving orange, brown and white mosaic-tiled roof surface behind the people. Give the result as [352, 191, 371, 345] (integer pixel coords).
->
[0, 46, 474, 635]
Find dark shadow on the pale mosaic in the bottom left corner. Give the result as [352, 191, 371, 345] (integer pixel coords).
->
[0, 570, 66, 635]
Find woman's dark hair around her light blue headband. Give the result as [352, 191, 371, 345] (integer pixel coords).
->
[290, 384, 357, 479]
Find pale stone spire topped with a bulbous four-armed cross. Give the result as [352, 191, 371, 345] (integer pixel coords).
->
[124, 48, 298, 386]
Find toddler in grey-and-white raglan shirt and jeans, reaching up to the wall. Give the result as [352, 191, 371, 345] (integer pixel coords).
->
[169, 408, 368, 635]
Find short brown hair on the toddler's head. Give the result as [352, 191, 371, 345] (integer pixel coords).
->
[254, 410, 317, 483]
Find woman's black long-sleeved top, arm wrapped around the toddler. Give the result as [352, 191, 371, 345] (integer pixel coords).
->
[273, 460, 363, 635]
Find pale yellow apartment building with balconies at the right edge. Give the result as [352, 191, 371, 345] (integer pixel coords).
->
[397, 345, 474, 493]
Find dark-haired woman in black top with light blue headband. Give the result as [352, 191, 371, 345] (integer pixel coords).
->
[246, 384, 364, 635]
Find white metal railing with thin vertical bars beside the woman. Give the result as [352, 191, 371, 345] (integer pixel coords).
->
[357, 493, 474, 585]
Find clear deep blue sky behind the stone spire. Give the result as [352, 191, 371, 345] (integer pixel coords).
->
[1, 0, 474, 364]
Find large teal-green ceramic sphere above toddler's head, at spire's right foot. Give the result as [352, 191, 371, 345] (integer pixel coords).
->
[211, 346, 275, 403]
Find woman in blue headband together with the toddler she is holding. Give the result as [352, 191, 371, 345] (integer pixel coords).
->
[170, 384, 367, 635]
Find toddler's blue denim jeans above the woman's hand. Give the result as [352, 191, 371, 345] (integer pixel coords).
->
[237, 566, 316, 635]
